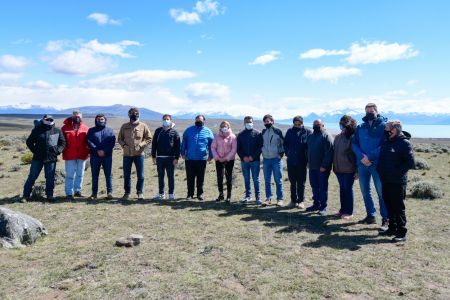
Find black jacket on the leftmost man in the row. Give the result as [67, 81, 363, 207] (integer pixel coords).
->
[26, 123, 66, 163]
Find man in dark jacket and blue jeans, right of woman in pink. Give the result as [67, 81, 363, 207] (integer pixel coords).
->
[237, 116, 263, 205]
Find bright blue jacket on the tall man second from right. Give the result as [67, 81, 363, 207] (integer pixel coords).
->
[352, 115, 387, 166]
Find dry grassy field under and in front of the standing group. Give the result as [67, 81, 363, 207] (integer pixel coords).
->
[0, 119, 450, 299]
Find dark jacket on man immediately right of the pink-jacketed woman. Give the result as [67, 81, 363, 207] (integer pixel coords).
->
[237, 129, 263, 161]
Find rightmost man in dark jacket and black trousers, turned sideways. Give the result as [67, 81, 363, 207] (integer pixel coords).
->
[377, 121, 415, 242]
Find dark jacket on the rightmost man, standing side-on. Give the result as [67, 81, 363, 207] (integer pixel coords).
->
[377, 131, 415, 184]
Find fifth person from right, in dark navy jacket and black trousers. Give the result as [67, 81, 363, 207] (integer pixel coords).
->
[283, 116, 312, 209]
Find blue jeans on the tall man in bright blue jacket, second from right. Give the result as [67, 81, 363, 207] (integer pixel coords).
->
[358, 164, 388, 219]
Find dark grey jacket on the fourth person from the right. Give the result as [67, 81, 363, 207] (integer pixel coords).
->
[307, 129, 333, 170]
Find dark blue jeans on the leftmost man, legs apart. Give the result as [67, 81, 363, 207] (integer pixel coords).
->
[23, 160, 56, 198]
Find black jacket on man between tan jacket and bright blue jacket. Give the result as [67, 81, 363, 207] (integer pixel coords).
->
[152, 127, 180, 159]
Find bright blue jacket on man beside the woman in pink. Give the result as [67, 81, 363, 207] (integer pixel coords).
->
[181, 125, 214, 160]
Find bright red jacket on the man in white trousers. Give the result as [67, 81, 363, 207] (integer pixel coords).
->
[61, 117, 89, 160]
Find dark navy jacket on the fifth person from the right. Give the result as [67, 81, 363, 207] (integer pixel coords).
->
[283, 127, 312, 167]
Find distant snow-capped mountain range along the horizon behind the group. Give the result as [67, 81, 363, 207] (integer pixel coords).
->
[0, 104, 450, 125]
